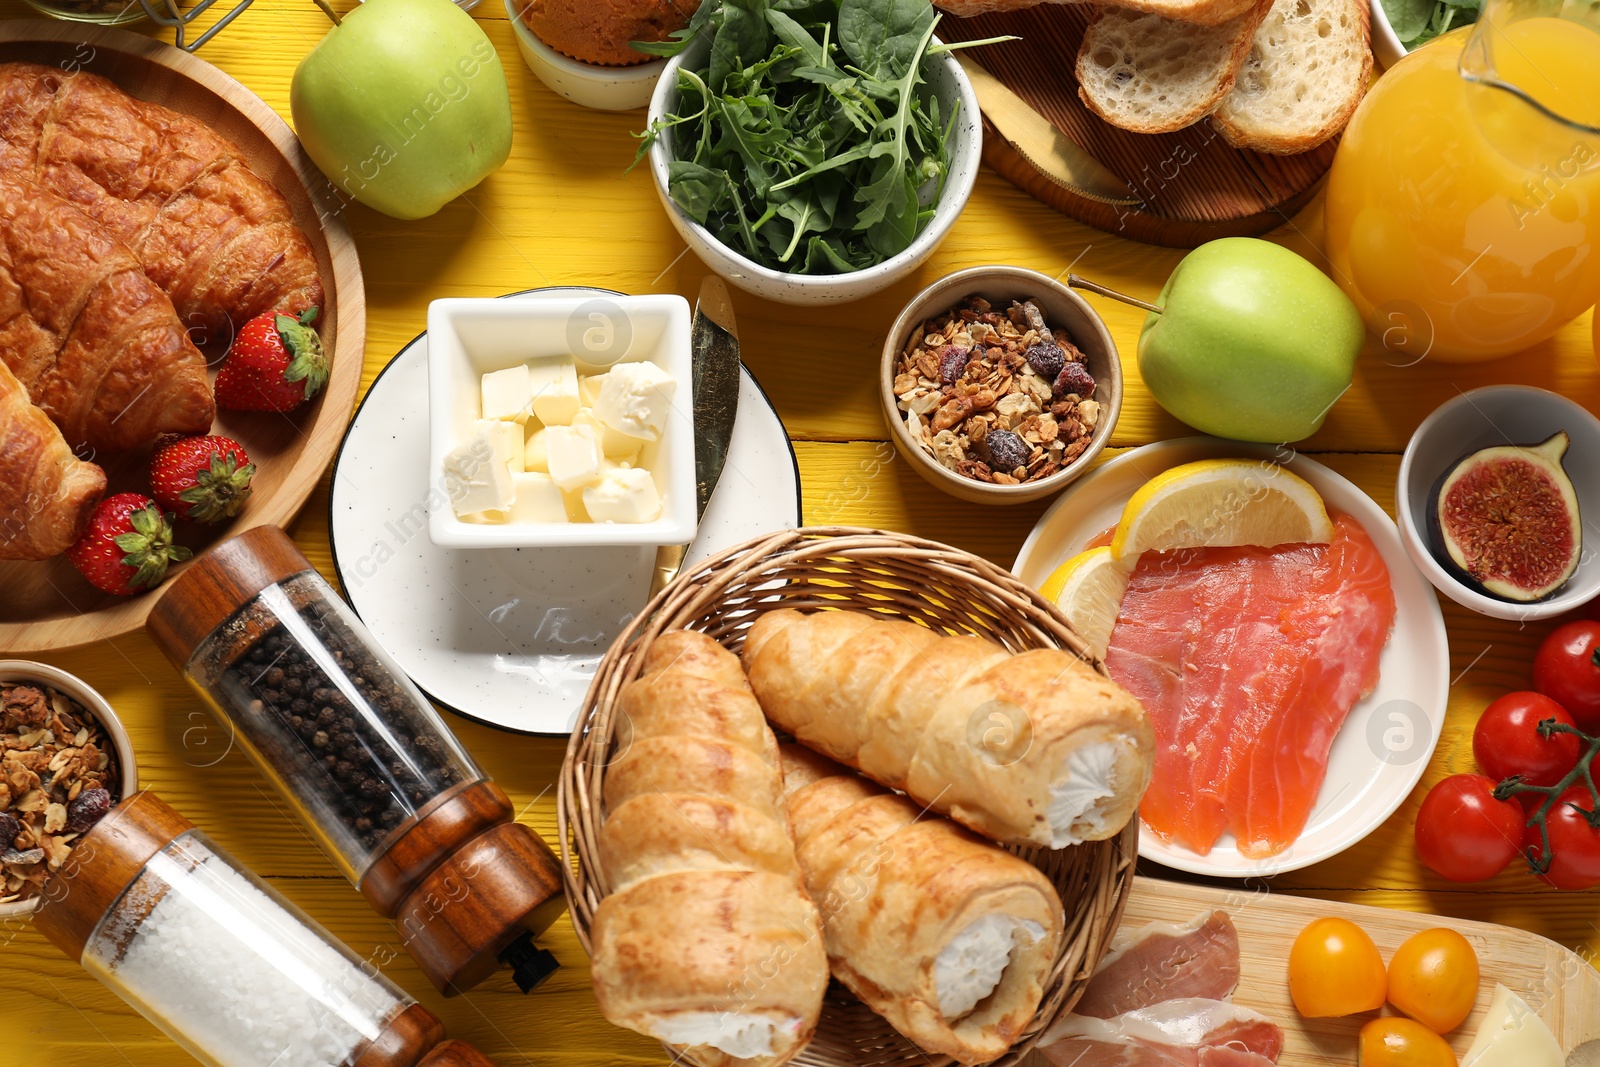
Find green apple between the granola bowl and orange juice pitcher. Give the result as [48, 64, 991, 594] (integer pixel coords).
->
[1139, 237, 1363, 443]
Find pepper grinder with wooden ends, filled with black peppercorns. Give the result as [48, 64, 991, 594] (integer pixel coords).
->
[149, 526, 565, 997]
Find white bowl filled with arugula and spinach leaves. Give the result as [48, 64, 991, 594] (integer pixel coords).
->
[640, 0, 982, 304]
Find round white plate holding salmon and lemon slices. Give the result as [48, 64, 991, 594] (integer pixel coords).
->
[1011, 437, 1450, 878]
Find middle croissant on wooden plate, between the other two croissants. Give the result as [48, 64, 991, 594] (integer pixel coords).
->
[0, 174, 216, 450]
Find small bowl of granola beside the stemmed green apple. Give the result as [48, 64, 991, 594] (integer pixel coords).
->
[882, 267, 1122, 504]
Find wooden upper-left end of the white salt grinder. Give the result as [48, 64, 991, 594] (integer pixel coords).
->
[34, 789, 194, 961]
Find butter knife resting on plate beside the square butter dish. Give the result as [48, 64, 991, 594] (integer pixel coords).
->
[650, 274, 739, 598]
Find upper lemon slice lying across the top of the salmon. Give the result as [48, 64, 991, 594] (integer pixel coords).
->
[1110, 459, 1333, 563]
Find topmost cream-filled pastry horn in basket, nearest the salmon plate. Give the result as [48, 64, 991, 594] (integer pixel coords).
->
[744, 608, 1155, 848]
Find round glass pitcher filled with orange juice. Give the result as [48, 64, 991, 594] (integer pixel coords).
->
[1326, 0, 1600, 363]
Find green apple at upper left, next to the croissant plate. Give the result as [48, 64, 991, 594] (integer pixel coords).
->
[290, 0, 510, 219]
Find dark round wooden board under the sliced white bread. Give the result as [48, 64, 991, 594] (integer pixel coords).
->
[938, 3, 1338, 248]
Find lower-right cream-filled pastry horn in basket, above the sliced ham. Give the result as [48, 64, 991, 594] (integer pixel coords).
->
[782, 745, 1062, 1064]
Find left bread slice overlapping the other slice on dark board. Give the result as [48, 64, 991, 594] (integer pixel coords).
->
[1077, 0, 1272, 133]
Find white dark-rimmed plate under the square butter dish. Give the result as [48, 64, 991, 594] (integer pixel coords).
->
[328, 288, 800, 734]
